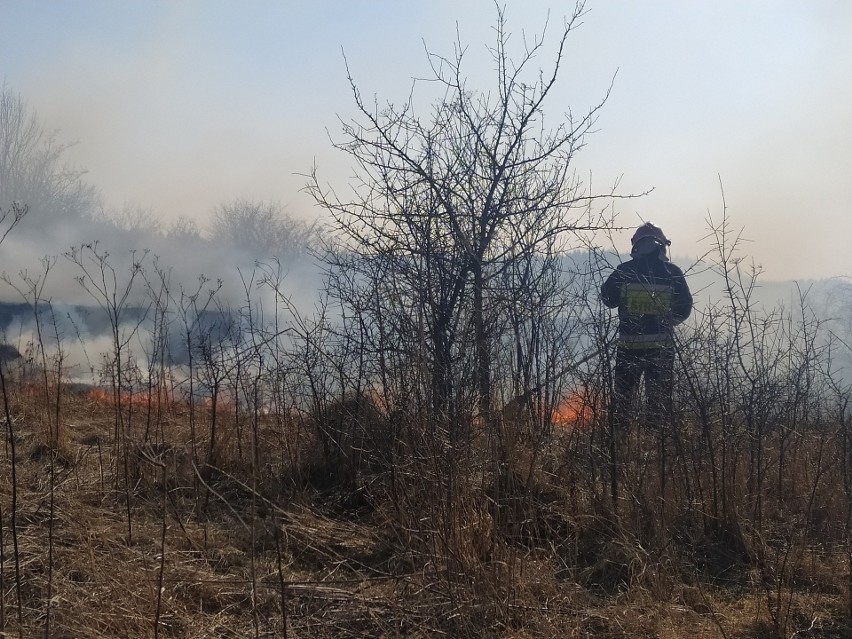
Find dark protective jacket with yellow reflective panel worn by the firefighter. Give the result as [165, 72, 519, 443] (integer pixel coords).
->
[601, 253, 692, 349]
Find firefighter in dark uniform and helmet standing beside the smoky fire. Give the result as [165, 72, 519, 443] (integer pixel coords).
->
[601, 222, 692, 436]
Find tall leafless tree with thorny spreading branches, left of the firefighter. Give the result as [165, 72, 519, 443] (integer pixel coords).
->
[307, 3, 608, 436]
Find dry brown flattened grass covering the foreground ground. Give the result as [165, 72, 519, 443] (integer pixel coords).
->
[0, 378, 852, 639]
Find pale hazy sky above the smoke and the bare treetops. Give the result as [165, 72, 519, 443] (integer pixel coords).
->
[0, 0, 852, 279]
